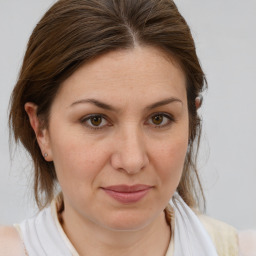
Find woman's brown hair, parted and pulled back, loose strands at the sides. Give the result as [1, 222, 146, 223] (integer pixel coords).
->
[9, 0, 206, 208]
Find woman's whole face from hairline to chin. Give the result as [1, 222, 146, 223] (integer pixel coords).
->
[41, 47, 188, 230]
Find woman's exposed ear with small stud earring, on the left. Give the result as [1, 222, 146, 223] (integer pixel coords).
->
[25, 102, 53, 161]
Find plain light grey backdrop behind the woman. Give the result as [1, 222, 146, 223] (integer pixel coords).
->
[0, 0, 256, 229]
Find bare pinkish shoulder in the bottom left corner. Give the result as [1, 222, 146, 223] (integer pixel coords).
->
[0, 226, 25, 256]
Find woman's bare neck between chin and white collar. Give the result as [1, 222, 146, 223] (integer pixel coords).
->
[61, 206, 171, 256]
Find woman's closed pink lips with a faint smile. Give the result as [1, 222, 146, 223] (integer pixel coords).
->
[102, 184, 153, 204]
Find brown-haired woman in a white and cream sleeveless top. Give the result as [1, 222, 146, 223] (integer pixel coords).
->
[0, 0, 253, 256]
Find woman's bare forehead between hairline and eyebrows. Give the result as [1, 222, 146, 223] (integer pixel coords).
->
[56, 47, 186, 108]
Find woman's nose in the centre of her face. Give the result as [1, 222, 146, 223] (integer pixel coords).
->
[111, 127, 149, 175]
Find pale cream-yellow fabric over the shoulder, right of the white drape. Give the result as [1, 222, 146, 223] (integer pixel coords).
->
[198, 215, 239, 256]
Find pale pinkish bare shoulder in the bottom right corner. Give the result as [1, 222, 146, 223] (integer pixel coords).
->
[238, 230, 256, 256]
